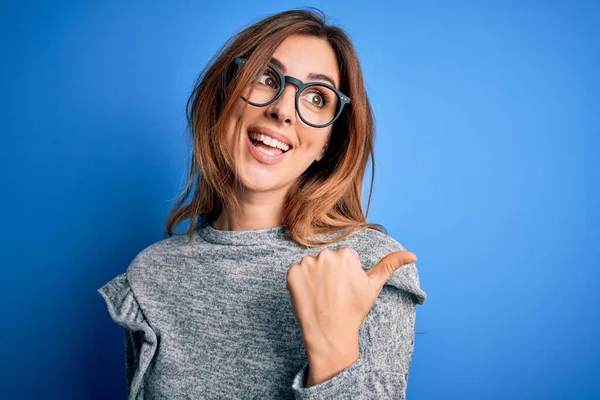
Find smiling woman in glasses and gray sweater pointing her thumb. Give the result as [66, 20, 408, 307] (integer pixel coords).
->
[99, 10, 426, 399]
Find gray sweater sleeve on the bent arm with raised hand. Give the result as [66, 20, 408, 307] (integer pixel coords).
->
[292, 264, 424, 400]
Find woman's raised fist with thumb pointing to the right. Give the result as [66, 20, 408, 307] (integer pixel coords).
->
[287, 247, 417, 382]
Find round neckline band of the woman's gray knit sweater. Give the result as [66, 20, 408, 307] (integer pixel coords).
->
[198, 224, 291, 246]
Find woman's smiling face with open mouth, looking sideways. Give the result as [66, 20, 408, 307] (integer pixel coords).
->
[227, 35, 339, 191]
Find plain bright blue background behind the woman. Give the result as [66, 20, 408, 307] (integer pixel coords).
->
[0, 1, 600, 399]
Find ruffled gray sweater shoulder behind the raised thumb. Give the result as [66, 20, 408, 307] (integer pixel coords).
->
[336, 228, 427, 304]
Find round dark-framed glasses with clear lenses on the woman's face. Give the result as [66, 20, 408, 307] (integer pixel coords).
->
[235, 57, 351, 128]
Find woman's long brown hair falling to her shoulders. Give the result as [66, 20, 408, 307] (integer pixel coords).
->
[165, 8, 387, 247]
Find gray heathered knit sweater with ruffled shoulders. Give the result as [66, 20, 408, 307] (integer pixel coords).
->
[98, 225, 426, 400]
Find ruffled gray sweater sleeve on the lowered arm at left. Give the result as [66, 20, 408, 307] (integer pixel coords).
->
[98, 273, 158, 400]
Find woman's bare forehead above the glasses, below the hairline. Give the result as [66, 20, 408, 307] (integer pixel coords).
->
[273, 35, 340, 85]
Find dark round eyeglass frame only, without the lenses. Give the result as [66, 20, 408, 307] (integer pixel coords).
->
[234, 57, 352, 128]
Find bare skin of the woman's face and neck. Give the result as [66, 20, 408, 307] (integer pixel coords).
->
[215, 35, 339, 230]
